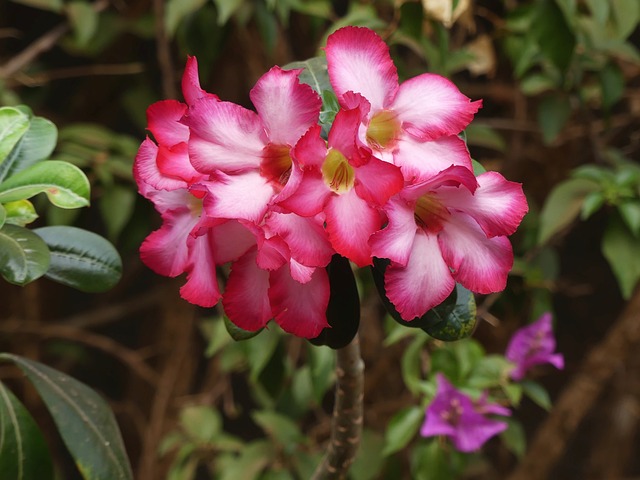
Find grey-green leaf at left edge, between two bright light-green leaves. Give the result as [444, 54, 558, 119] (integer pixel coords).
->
[0, 117, 58, 182]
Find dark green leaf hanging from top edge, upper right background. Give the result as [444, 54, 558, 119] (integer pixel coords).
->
[531, 0, 576, 73]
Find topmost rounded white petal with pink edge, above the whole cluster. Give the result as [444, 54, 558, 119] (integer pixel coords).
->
[325, 27, 398, 111]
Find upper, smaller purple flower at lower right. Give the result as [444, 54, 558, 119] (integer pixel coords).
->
[505, 312, 564, 380]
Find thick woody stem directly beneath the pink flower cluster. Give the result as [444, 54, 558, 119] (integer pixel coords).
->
[312, 335, 364, 480]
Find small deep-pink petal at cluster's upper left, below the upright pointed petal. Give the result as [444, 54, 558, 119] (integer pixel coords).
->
[147, 100, 189, 147]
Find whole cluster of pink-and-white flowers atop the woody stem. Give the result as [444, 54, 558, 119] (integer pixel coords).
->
[134, 27, 527, 338]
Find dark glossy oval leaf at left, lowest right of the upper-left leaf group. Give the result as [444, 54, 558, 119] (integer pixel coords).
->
[34, 226, 122, 293]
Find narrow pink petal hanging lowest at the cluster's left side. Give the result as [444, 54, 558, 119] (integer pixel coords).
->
[180, 233, 221, 308]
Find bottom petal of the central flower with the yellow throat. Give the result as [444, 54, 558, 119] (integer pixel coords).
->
[324, 189, 382, 267]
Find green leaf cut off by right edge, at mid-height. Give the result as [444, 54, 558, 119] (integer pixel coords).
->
[602, 215, 640, 300]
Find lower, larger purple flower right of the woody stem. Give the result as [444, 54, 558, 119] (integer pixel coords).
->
[420, 373, 511, 452]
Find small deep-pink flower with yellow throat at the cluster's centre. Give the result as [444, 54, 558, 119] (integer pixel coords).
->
[279, 102, 403, 267]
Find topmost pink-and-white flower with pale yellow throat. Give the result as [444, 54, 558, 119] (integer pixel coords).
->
[326, 27, 482, 180]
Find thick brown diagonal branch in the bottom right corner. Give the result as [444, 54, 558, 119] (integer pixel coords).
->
[509, 287, 640, 480]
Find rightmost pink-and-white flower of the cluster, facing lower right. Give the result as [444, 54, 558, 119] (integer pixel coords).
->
[370, 166, 528, 321]
